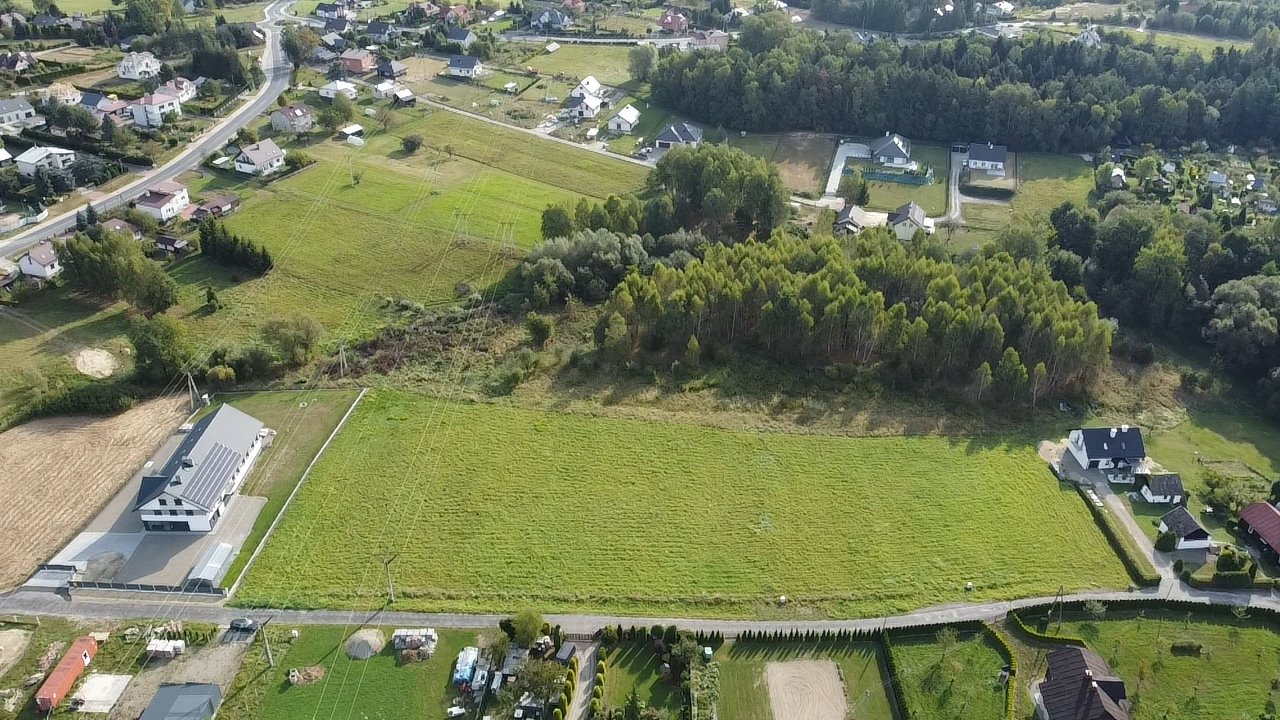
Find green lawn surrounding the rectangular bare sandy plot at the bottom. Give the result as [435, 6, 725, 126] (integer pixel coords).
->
[713, 641, 893, 720]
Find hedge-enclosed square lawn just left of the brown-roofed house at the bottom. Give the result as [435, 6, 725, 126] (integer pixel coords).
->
[890, 625, 1009, 720]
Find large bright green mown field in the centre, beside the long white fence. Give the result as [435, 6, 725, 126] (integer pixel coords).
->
[239, 391, 1128, 616]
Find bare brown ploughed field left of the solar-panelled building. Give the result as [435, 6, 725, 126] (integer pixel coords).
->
[0, 398, 187, 591]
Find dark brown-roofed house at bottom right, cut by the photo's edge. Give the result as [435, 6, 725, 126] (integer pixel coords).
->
[1032, 647, 1130, 720]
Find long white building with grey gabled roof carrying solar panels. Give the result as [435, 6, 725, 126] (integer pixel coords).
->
[133, 405, 273, 533]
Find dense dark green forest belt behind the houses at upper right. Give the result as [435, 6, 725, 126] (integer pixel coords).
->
[653, 13, 1280, 151]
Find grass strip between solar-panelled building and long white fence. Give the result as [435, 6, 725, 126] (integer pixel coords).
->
[205, 389, 358, 587]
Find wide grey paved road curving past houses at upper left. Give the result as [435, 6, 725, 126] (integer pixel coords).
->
[0, 0, 294, 258]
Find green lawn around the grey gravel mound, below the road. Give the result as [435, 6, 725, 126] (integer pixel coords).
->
[218, 624, 479, 720]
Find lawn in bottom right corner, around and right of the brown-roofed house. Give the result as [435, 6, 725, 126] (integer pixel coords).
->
[1027, 610, 1280, 720]
